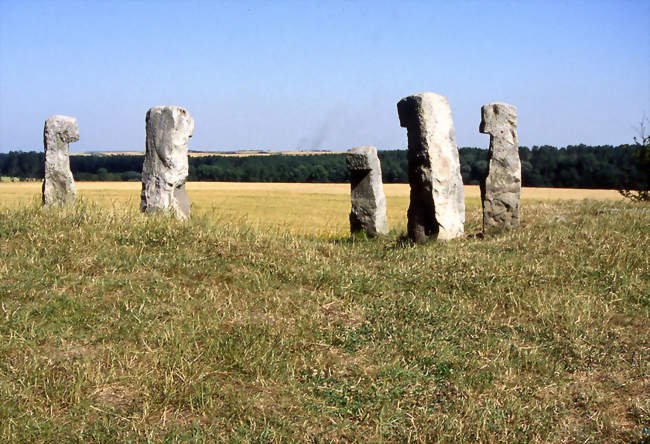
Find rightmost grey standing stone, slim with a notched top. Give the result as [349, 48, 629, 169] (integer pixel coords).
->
[479, 103, 521, 232]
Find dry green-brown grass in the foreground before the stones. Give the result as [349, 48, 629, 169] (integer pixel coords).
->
[0, 201, 650, 442]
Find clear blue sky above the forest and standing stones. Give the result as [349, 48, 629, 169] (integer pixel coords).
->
[0, 0, 650, 152]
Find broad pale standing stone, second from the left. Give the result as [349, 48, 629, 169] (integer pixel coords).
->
[140, 106, 194, 219]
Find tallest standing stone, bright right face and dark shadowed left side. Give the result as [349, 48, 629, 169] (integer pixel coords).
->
[397, 93, 465, 243]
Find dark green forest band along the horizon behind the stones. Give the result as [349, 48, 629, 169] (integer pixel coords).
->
[0, 145, 650, 189]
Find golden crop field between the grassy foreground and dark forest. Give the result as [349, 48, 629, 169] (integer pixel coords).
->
[0, 182, 622, 235]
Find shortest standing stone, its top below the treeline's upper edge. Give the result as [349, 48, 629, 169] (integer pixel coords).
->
[346, 146, 388, 237]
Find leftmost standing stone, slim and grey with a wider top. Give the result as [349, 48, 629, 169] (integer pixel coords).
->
[43, 115, 79, 207]
